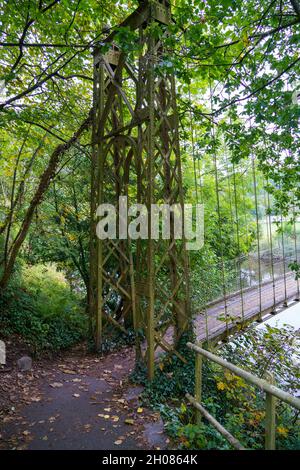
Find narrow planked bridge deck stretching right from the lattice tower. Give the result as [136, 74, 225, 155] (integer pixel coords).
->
[195, 274, 298, 341]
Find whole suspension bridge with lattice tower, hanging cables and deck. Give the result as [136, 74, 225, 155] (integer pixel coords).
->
[89, 0, 299, 379]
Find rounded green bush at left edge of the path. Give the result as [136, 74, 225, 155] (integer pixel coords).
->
[0, 266, 87, 353]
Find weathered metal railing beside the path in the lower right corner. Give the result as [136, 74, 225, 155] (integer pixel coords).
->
[186, 343, 300, 450]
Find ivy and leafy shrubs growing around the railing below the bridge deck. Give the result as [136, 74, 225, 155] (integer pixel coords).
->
[133, 327, 300, 449]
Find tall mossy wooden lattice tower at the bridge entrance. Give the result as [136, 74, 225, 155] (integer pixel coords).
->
[90, 1, 190, 378]
